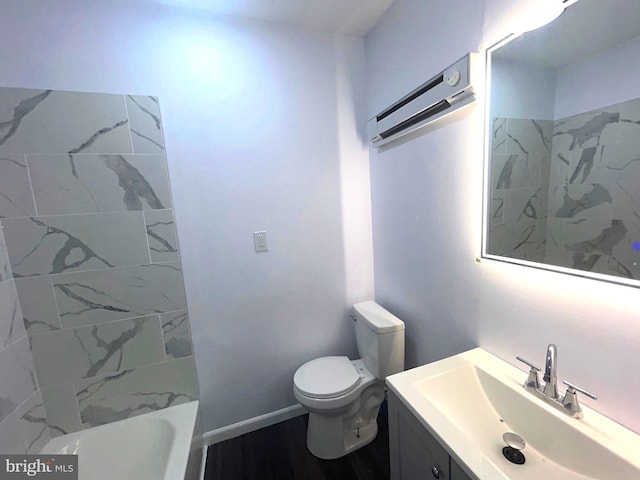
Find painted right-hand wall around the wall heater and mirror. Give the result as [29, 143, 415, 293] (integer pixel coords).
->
[366, 0, 640, 432]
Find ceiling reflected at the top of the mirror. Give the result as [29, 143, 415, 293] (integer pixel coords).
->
[494, 0, 640, 69]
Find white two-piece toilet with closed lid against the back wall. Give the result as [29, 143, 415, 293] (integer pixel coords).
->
[293, 301, 404, 460]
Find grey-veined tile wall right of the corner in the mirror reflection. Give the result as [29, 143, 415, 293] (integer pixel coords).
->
[546, 99, 640, 279]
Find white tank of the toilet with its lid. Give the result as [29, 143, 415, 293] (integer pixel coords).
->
[353, 300, 404, 380]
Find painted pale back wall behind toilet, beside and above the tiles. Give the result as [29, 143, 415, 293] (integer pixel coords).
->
[0, 0, 373, 431]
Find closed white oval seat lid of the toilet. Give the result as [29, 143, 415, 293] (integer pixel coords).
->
[293, 357, 361, 399]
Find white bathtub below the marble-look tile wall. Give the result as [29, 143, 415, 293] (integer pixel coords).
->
[41, 401, 198, 480]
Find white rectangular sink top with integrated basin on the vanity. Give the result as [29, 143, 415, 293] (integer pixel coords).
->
[387, 348, 640, 480]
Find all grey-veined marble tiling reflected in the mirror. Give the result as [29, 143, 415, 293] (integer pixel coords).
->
[487, 95, 640, 279]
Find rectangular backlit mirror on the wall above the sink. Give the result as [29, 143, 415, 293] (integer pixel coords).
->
[483, 0, 640, 286]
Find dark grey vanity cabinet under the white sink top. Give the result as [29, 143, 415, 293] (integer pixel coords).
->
[388, 390, 474, 480]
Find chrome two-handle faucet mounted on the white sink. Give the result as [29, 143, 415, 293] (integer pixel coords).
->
[516, 343, 598, 418]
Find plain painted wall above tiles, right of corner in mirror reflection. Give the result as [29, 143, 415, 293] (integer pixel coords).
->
[555, 37, 640, 118]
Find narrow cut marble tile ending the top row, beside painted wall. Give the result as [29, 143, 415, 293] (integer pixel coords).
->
[127, 95, 164, 153]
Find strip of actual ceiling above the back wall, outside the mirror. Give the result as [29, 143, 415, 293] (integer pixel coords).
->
[132, 0, 393, 37]
